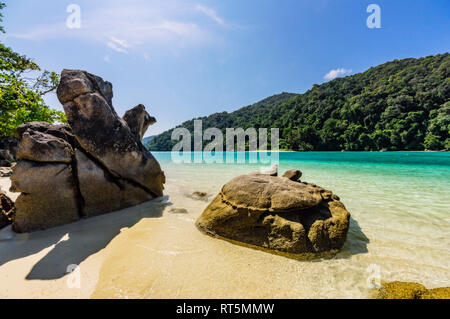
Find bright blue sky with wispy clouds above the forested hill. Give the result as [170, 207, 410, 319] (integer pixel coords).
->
[0, 0, 450, 136]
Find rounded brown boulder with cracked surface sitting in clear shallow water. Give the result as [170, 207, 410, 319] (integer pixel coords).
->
[196, 173, 350, 257]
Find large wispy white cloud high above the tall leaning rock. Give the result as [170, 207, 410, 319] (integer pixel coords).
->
[7, 0, 220, 56]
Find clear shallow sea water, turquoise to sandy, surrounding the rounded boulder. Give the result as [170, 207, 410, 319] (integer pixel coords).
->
[93, 152, 450, 298]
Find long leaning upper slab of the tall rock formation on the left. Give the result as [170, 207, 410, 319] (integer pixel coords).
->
[57, 70, 165, 197]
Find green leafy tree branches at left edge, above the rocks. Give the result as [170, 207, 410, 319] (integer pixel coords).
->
[0, 3, 66, 136]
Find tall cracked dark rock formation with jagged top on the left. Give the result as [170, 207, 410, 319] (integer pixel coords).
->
[11, 70, 165, 232]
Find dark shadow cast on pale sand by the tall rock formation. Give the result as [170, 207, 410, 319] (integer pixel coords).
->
[0, 196, 171, 280]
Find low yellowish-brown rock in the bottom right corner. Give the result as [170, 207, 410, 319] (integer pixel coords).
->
[375, 281, 450, 299]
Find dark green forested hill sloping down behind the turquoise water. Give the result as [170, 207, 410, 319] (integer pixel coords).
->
[147, 53, 450, 151]
